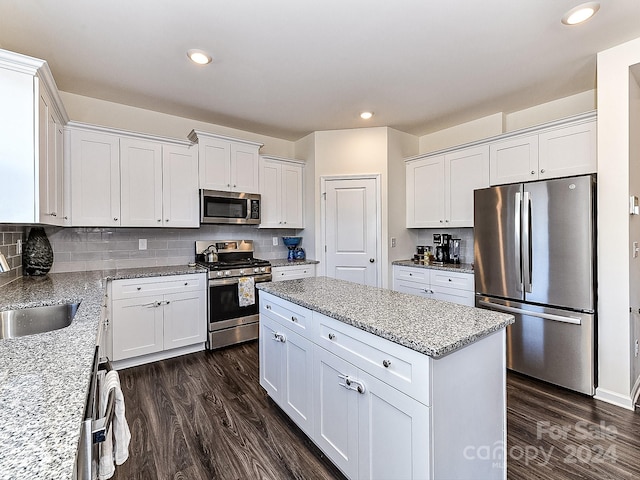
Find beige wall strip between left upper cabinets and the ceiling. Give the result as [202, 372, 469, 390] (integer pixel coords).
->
[60, 92, 294, 157]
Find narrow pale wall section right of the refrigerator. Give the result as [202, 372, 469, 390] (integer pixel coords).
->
[596, 35, 640, 409]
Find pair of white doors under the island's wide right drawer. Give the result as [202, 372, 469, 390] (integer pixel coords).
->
[313, 346, 429, 479]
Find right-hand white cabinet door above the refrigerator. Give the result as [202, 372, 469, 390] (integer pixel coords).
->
[538, 122, 598, 179]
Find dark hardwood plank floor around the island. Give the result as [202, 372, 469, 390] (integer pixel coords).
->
[114, 342, 640, 480]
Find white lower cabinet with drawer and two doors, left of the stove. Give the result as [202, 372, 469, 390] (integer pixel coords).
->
[107, 274, 207, 367]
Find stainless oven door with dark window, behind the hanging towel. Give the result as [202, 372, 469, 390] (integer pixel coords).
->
[209, 274, 271, 331]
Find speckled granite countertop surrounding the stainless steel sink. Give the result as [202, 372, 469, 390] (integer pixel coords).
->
[0, 266, 206, 480]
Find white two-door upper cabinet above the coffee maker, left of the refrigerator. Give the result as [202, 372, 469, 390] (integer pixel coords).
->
[406, 145, 489, 228]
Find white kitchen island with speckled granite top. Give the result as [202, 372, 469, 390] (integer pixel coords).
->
[258, 277, 513, 479]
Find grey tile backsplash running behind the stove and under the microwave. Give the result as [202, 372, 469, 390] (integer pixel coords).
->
[45, 225, 304, 273]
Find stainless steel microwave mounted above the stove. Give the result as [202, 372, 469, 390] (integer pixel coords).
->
[200, 190, 260, 225]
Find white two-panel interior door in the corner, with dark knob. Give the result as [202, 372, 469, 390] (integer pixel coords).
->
[324, 178, 381, 286]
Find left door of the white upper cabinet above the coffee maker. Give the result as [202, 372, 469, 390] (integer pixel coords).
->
[406, 155, 446, 228]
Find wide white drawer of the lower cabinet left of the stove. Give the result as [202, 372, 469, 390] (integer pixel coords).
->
[112, 274, 206, 299]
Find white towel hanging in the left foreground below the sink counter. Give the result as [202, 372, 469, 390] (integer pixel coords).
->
[98, 370, 131, 480]
